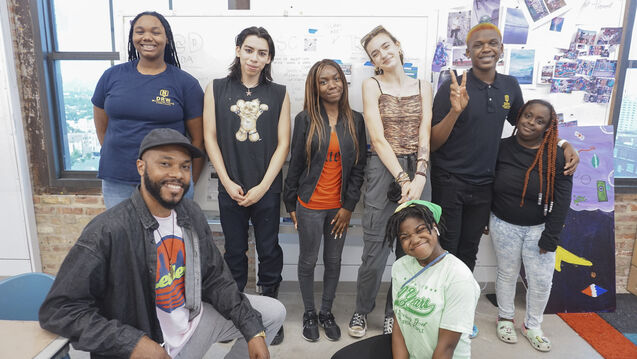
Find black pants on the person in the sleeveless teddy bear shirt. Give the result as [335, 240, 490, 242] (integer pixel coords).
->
[219, 192, 283, 293]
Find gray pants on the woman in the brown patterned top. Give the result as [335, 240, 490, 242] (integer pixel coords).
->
[356, 155, 431, 316]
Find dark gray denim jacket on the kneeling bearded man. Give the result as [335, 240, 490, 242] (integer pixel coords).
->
[40, 190, 265, 358]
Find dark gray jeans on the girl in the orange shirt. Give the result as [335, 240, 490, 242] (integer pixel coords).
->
[296, 202, 347, 312]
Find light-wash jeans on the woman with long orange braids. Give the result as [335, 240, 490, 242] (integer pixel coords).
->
[489, 213, 555, 329]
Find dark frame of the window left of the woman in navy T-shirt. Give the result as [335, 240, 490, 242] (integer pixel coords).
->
[29, 0, 120, 190]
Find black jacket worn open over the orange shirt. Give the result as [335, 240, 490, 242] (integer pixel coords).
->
[283, 107, 367, 212]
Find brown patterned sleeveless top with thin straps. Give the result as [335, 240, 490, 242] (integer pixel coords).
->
[372, 77, 422, 155]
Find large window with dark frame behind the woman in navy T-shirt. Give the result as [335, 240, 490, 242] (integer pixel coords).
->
[31, 0, 172, 187]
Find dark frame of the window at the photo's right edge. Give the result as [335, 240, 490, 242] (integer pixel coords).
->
[611, 0, 637, 193]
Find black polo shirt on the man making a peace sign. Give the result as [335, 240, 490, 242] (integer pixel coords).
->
[431, 70, 524, 185]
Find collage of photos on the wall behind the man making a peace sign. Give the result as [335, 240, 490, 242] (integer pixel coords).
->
[432, 0, 622, 103]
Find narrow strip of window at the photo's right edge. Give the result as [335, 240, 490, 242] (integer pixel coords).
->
[613, 0, 637, 192]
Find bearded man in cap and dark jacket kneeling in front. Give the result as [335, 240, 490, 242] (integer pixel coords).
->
[40, 129, 285, 359]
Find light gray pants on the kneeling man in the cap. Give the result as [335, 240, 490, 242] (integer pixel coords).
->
[176, 294, 285, 359]
